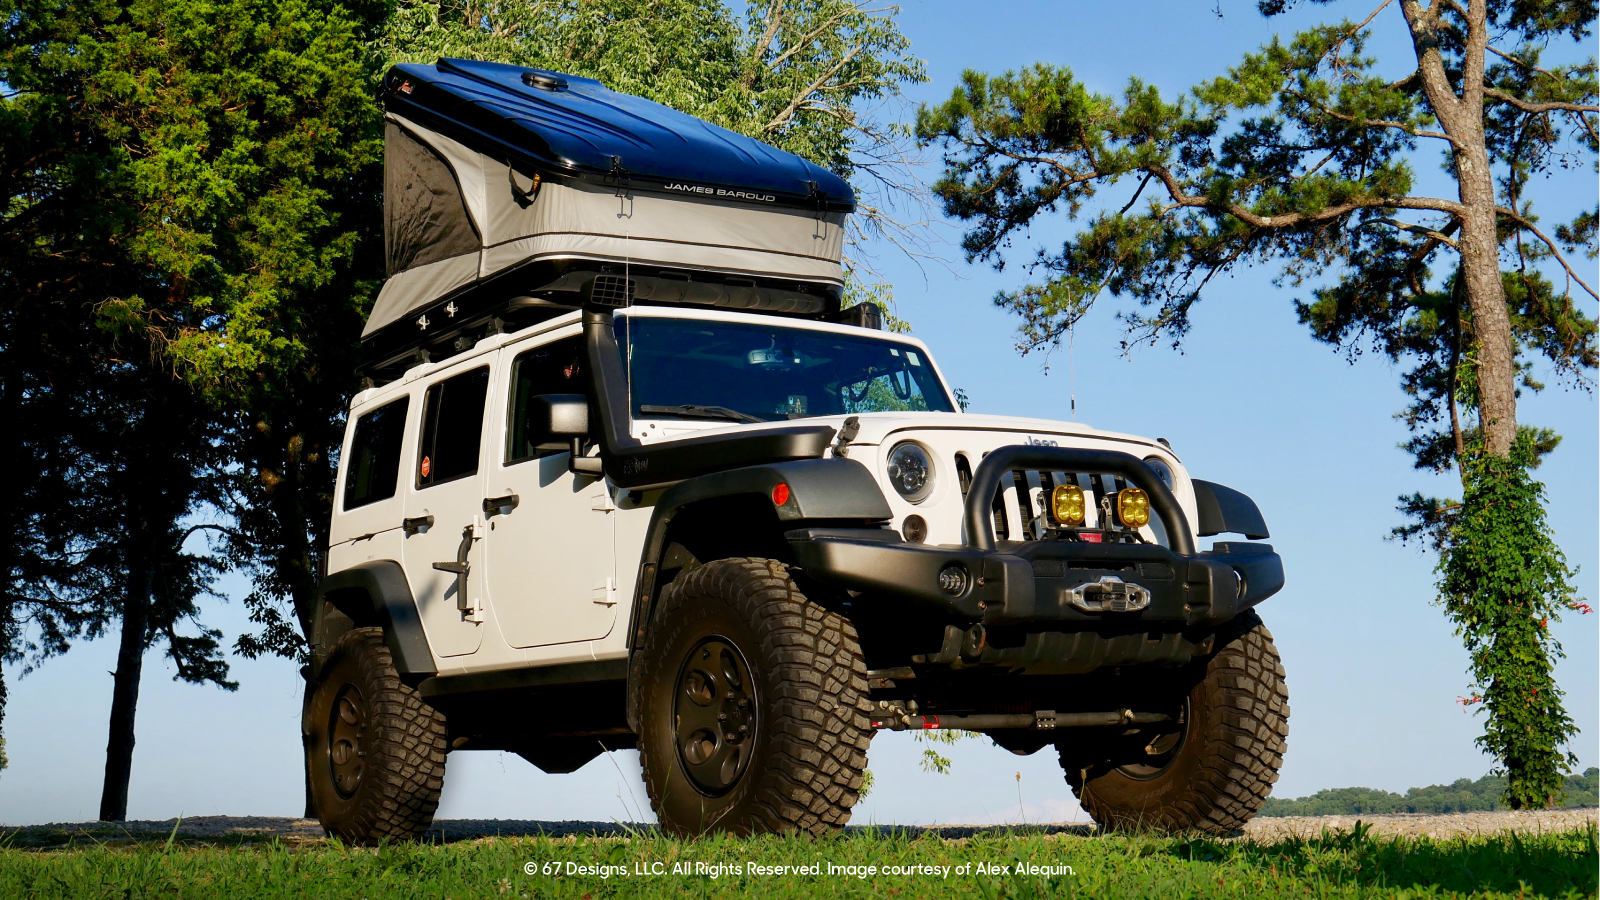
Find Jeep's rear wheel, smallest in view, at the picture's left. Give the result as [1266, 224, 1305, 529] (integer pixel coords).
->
[306, 628, 446, 844]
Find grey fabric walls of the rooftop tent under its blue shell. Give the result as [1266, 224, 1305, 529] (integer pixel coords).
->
[362, 105, 845, 338]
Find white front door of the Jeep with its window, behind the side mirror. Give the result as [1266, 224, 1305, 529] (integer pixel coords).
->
[483, 336, 618, 647]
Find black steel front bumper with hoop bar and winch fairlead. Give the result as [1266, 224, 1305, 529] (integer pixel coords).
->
[786, 447, 1283, 671]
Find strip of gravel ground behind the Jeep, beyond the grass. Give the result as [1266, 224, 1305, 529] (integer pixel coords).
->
[0, 807, 1600, 847]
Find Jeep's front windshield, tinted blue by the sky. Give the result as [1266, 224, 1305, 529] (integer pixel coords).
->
[616, 315, 955, 421]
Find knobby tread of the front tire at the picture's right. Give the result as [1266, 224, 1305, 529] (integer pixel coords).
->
[1061, 610, 1290, 834]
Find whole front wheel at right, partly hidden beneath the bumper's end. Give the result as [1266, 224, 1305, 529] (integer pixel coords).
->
[1061, 612, 1290, 834]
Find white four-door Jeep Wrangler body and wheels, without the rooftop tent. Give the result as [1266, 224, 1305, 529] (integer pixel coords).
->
[306, 297, 1288, 839]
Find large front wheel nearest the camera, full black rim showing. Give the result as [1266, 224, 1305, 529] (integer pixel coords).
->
[637, 559, 872, 836]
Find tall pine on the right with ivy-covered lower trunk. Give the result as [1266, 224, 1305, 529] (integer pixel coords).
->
[917, 0, 1600, 807]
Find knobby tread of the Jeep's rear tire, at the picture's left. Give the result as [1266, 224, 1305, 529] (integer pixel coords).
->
[310, 628, 448, 846]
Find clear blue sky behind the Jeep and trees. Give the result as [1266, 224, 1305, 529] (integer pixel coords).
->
[0, 0, 1600, 823]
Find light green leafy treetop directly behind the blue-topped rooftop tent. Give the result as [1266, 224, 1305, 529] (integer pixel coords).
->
[381, 0, 926, 274]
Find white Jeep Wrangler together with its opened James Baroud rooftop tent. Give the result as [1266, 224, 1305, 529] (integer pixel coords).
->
[302, 59, 1288, 842]
